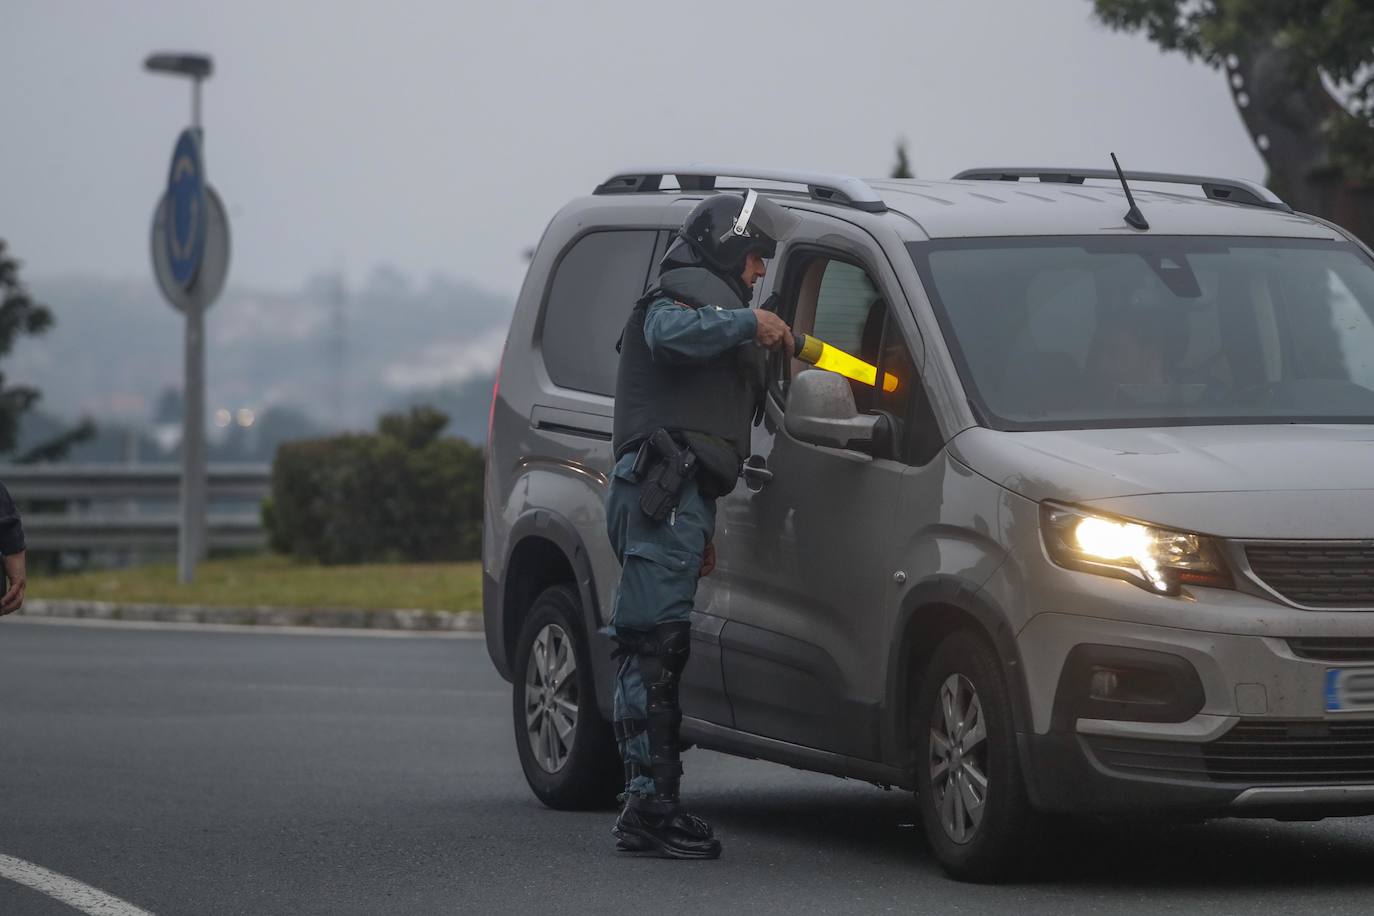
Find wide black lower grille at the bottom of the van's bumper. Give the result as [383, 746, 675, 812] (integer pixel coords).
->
[1087, 720, 1374, 786]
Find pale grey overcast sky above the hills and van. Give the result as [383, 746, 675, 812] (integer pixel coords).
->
[0, 0, 1263, 294]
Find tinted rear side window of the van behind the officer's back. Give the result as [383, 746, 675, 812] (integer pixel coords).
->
[540, 229, 658, 397]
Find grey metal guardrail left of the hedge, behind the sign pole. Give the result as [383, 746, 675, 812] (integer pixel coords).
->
[0, 464, 272, 552]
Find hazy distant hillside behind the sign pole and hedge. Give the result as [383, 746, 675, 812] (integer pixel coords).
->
[9, 268, 511, 452]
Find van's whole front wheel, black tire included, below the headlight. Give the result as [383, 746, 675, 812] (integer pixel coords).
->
[911, 630, 1032, 882]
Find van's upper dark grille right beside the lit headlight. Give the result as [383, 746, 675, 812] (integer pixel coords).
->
[1245, 542, 1374, 607]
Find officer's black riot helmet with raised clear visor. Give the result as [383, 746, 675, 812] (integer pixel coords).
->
[662, 191, 801, 277]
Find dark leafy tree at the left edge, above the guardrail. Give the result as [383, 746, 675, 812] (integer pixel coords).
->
[0, 239, 95, 464]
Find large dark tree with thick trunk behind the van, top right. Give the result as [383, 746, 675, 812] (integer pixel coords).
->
[1094, 0, 1374, 244]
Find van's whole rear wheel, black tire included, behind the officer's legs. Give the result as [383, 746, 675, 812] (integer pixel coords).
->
[511, 585, 625, 810]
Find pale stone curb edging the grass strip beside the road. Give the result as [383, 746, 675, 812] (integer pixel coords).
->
[18, 599, 482, 632]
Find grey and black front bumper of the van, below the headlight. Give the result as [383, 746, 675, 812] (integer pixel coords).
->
[1018, 614, 1374, 818]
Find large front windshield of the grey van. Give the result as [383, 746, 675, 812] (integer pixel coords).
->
[910, 236, 1374, 430]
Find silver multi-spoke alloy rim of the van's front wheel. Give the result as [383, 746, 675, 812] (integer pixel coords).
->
[929, 674, 988, 843]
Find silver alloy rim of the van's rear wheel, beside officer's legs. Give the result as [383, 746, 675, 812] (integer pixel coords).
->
[525, 623, 577, 773]
